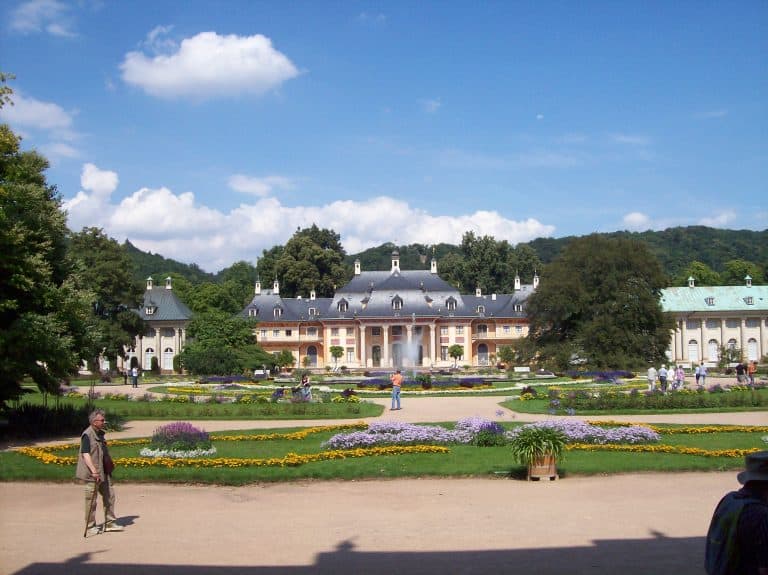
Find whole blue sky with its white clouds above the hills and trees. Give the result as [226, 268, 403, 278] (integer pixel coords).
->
[0, 0, 768, 271]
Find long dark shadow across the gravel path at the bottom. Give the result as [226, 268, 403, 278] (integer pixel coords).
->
[14, 533, 704, 575]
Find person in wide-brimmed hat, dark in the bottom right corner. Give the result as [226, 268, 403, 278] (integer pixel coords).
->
[705, 451, 768, 575]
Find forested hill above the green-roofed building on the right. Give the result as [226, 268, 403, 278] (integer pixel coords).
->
[527, 226, 768, 277]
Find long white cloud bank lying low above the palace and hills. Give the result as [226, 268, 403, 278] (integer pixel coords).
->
[58, 164, 555, 271]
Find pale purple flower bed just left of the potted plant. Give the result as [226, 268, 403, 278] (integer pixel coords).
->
[323, 417, 504, 449]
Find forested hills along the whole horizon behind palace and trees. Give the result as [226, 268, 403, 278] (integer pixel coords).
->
[125, 226, 768, 284]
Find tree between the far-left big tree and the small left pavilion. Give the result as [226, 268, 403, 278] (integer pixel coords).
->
[68, 228, 144, 365]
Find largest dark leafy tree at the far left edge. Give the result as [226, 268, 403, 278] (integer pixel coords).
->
[0, 121, 89, 402]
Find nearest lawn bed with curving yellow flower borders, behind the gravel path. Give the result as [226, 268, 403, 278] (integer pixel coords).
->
[0, 418, 768, 485]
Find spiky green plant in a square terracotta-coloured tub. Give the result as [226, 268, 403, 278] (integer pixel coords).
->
[510, 425, 567, 481]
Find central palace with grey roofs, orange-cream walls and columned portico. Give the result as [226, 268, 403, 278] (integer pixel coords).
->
[241, 251, 538, 369]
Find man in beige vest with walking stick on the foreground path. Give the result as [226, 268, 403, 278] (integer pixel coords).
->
[75, 409, 123, 537]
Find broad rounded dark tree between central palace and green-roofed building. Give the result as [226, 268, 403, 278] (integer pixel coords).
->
[527, 234, 671, 369]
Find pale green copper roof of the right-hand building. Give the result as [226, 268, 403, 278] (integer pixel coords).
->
[661, 285, 768, 312]
